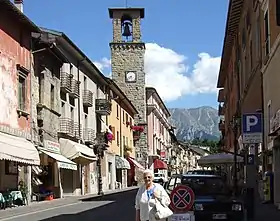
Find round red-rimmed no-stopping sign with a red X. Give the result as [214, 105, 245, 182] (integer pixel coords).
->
[170, 185, 195, 212]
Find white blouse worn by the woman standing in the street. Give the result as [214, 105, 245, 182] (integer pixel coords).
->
[135, 183, 170, 221]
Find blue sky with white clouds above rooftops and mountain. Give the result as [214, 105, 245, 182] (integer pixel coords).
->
[24, 0, 228, 108]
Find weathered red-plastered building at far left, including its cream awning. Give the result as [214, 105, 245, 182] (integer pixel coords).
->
[0, 0, 40, 202]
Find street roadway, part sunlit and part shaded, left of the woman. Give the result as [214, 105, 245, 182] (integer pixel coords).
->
[0, 190, 136, 221]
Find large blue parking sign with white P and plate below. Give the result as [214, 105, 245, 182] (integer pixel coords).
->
[242, 113, 262, 144]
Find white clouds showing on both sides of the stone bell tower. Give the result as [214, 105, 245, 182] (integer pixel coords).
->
[95, 43, 221, 101]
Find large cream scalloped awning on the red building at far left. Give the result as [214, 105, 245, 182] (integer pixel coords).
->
[0, 132, 40, 165]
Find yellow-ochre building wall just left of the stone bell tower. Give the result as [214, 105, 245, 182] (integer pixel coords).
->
[108, 100, 135, 158]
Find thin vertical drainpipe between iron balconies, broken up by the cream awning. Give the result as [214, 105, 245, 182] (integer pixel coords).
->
[77, 58, 86, 195]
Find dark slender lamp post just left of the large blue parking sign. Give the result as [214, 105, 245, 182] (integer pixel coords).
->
[230, 115, 239, 195]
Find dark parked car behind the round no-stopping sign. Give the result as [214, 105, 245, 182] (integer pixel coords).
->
[165, 174, 244, 221]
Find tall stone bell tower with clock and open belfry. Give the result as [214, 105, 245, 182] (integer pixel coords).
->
[109, 8, 148, 166]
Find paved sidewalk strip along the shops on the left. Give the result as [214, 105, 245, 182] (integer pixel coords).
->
[0, 186, 139, 220]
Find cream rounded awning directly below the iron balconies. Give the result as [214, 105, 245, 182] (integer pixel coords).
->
[59, 138, 97, 164]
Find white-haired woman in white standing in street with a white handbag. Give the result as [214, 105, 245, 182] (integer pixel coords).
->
[135, 170, 170, 221]
